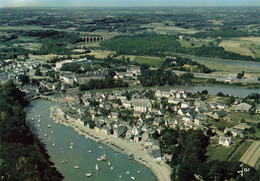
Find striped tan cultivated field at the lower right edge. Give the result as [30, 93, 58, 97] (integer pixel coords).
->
[239, 141, 260, 167]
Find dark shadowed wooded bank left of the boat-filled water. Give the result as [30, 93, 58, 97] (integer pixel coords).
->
[0, 81, 63, 181]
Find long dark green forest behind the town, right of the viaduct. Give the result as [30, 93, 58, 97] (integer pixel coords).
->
[100, 33, 260, 61]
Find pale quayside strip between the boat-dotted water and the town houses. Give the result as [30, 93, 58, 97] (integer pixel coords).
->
[50, 107, 171, 181]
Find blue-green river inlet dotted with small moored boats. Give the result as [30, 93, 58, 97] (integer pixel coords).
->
[25, 99, 156, 181]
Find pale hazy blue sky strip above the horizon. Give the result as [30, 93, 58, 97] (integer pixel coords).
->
[0, 0, 260, 7]
